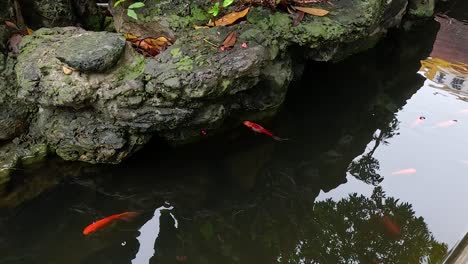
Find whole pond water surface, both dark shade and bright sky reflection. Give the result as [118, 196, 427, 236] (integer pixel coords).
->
[0, 10, 468, 264]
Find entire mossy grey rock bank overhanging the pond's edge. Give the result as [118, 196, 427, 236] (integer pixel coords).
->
[0, 0, 428, 163]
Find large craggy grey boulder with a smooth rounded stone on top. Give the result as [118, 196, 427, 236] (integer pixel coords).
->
[16, 28, 292, 163]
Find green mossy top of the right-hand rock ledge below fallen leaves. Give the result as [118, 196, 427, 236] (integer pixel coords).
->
[241, 0, 384, 51]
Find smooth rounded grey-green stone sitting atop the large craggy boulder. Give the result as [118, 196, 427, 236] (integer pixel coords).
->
[56, 32, 125, 72]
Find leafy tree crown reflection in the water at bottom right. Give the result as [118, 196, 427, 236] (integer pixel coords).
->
[285, 187, 447, 263]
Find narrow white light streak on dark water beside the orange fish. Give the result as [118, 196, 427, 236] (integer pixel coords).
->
[132, 206, 177, 264]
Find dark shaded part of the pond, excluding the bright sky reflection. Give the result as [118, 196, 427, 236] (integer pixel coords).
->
[0, 23, 447, 264]
